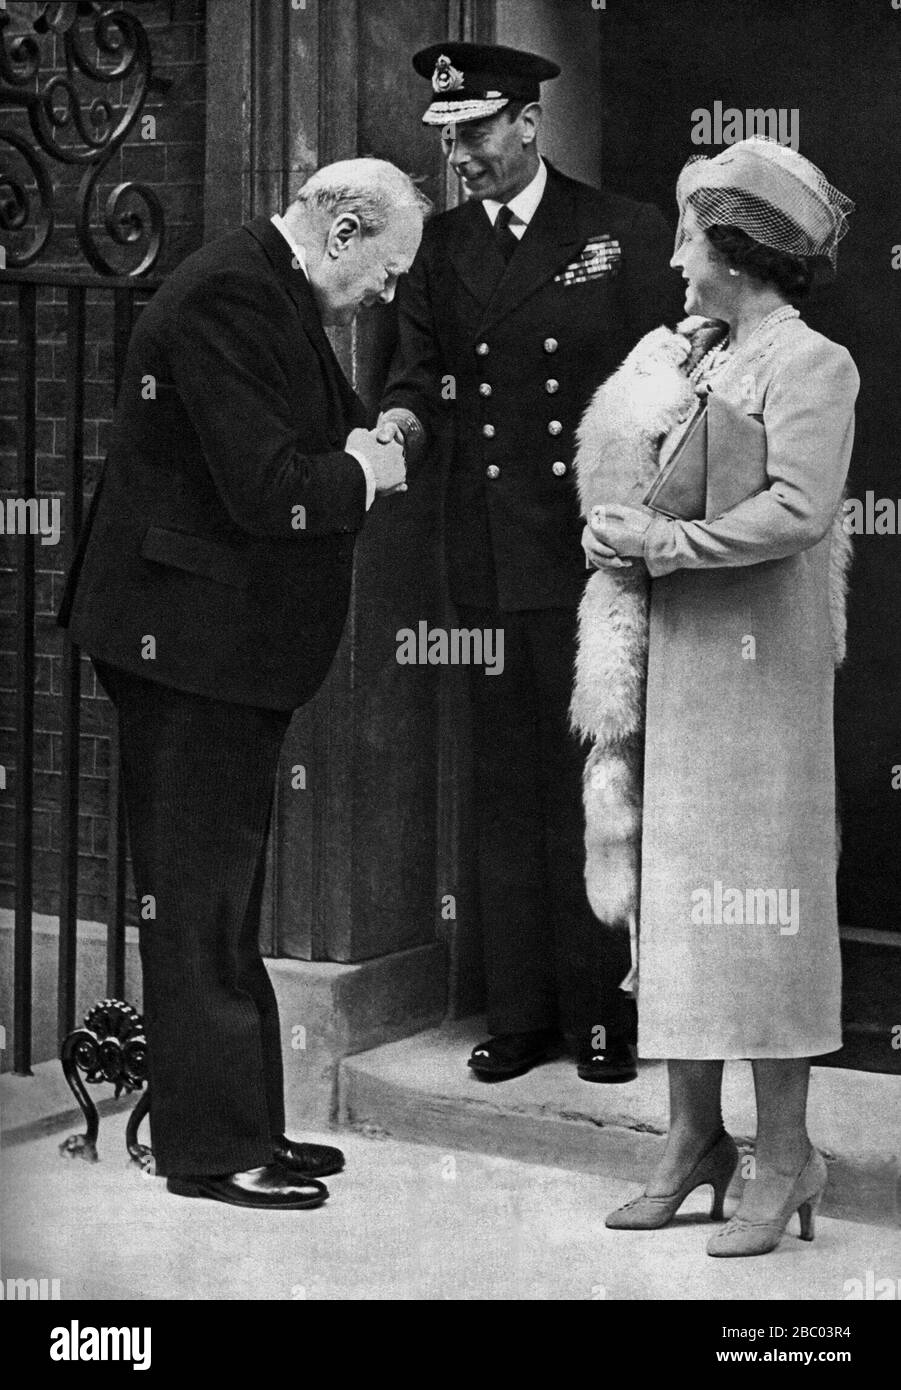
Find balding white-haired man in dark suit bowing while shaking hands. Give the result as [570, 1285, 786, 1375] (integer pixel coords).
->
[60, 160, 427, 1208]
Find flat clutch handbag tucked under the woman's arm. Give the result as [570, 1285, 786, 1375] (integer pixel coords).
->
[644, 392, 769, 521]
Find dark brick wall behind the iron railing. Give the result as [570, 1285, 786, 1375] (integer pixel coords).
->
[0, 0, 206, 920]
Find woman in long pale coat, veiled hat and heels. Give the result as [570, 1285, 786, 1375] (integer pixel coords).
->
[573, 138, 858, 1255]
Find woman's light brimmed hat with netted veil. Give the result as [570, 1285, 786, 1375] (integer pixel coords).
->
[676, 135, 854, 275]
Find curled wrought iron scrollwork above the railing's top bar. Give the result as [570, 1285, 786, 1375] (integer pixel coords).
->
[0, 0, 171, 277]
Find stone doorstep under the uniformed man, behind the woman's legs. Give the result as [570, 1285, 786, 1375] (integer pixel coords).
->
[339, 1019, 901, 1226]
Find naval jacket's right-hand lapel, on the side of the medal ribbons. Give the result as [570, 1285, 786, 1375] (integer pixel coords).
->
[478, 165, 587, 334]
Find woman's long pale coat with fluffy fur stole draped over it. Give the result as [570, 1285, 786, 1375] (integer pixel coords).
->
[573, 320, 859, 1058]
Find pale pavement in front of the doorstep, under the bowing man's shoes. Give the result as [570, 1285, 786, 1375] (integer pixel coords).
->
[0, 1095, 901, 1301]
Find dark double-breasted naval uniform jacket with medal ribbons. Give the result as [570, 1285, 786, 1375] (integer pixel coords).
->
[384, 165, 681, 610]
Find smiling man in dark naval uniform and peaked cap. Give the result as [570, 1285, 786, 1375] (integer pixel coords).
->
[382, 43, 680, 1081]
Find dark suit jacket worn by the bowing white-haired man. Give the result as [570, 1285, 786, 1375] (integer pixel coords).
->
[60, 217, 366, 709]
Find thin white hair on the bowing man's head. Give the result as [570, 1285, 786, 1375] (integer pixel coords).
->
[295, 158, 432, 236]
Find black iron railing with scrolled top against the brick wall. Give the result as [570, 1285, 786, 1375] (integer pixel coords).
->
[0, 0, 172, 1073]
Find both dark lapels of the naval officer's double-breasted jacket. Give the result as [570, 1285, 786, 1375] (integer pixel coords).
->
[451, 164, 586, 334]
